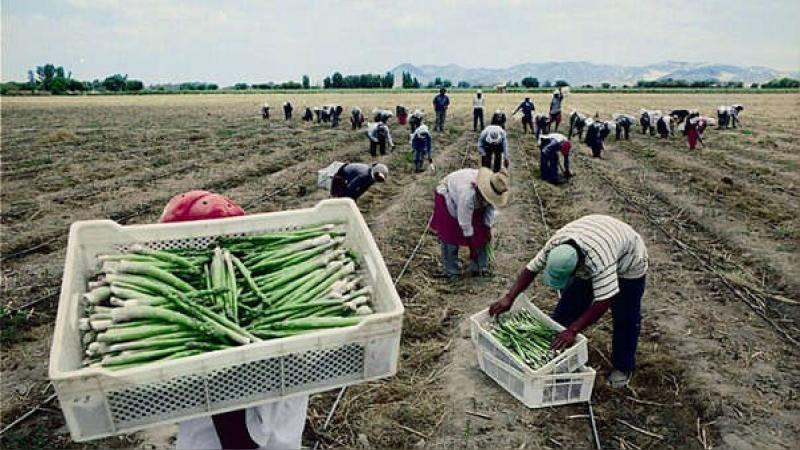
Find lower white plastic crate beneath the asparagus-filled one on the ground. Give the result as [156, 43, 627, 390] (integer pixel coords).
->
[478, 353, 596, 408]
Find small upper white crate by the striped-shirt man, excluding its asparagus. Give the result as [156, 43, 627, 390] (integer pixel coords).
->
[470, 294, 589, 375]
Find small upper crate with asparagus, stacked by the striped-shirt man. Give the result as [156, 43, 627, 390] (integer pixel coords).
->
[470, 294, 589, 375]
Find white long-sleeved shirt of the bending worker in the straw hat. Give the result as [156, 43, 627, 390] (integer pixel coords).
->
[436, 169, 495, 237]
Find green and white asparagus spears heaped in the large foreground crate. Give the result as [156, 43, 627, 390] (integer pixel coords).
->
[80, 225, 372, 369]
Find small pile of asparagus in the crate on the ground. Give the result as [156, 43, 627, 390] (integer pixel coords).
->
[491, 311, 558, 370]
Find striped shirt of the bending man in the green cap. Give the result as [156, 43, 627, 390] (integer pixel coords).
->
[527, 214, 647, 301]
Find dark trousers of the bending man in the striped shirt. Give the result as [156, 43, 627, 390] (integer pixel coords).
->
[552, 276, 646, 373]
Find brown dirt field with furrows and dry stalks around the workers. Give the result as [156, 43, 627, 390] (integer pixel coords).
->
[0, 93, 800, 449]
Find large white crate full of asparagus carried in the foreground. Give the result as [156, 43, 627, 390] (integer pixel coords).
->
[49, 199, 403, 441]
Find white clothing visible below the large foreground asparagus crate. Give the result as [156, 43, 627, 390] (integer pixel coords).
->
[175, 395, 308, 450]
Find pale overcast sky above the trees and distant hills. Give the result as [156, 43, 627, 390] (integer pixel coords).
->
[2, 0, 800, 85]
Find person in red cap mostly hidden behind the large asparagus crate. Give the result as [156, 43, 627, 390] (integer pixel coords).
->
[160, 191, 308, 450]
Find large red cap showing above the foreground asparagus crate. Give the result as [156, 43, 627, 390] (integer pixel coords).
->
[160, 191, 244, 223]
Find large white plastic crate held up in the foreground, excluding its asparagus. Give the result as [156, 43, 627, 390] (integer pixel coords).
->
[49, 199, 403, 441]
